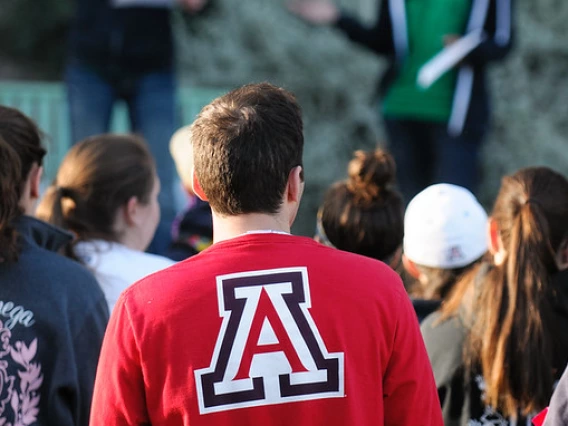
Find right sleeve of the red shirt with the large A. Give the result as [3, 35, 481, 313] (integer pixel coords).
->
[383, 294, 444, 426]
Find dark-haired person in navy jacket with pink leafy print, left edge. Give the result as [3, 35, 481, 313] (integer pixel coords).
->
[0, 106, 108, 426]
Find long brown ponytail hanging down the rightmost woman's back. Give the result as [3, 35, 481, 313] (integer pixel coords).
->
[477, 202, 555, 415]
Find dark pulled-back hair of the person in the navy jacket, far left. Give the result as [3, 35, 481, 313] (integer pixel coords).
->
[0, 105, 45, 262]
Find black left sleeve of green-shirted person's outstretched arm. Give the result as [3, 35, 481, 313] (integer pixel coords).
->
[335, 0, 394, 55]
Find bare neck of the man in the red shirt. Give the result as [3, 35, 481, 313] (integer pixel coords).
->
[213, 213, 290, 243]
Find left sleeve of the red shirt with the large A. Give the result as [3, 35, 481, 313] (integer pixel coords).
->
[90, 295, 150, 426]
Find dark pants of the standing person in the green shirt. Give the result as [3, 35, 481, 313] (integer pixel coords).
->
[385, 119, 485, 203]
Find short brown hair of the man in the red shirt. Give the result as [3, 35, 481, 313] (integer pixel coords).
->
[192, 83, 304, 215]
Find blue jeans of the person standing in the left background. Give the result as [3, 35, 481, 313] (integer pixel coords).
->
[65, 61, 177, 251]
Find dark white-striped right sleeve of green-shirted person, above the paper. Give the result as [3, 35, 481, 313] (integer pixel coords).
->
[465, 0, 513, 66]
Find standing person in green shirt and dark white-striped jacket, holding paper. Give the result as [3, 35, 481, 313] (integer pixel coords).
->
[290, 0, 513, 200]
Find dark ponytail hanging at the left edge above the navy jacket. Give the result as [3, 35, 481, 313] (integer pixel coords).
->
[0, 137, 21, 263]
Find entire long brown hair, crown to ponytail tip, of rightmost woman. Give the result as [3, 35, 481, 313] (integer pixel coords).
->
[443, 167, 568, 416]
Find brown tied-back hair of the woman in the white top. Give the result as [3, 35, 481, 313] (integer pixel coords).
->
[36, 134, 155, 246]
